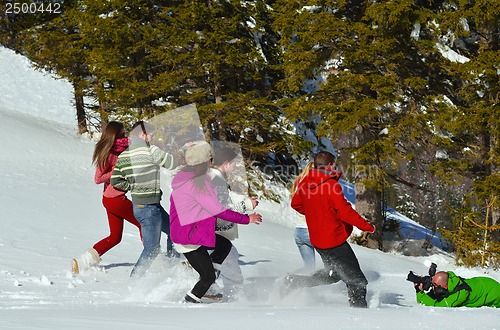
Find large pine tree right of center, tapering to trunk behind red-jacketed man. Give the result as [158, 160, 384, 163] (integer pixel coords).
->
[276, 0, 452, 247]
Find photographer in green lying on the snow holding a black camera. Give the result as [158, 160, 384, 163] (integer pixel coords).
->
[407, 264, 500, 307]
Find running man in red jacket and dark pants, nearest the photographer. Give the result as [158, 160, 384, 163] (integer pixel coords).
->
[282, 151, 375, 308]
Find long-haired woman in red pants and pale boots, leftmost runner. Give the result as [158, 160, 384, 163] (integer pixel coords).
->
[71, 121, 142, 274]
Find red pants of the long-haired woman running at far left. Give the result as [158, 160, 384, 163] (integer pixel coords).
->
[94, 196, 142, 256]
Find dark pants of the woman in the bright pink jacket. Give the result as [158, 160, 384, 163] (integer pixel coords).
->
[184, 235, 232, 298]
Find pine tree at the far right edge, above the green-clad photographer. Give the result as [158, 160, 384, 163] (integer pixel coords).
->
[424, 0, 500, 262]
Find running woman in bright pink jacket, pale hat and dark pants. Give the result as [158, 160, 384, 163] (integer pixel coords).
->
[170, 141, 262, 303]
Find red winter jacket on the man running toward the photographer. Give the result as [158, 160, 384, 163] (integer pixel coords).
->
[292, 169, 375, 249]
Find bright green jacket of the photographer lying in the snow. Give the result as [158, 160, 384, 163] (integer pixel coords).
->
[417, 272, 500, 307]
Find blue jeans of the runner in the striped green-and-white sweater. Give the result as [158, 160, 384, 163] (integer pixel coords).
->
[130, 204, 173, 277]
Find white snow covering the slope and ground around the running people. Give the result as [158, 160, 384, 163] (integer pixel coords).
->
[0, 47, 500, 330]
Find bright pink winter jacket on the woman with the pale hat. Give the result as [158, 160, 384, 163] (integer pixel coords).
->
[170, 171, 250, 247]
